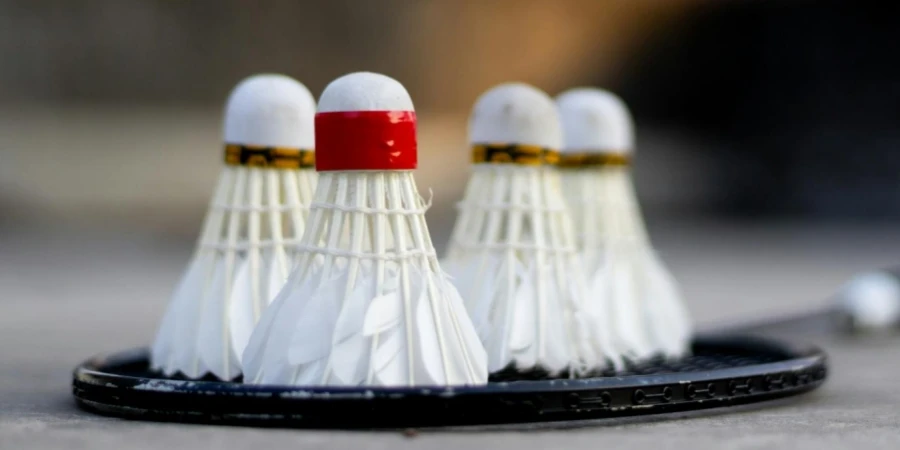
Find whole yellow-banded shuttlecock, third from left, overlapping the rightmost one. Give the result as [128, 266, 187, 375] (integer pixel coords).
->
[444, 83, 620, 376]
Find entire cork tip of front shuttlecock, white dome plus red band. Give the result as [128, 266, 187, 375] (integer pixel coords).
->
[316, 72, 418, 172]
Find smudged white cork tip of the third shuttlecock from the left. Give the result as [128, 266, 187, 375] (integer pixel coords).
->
[469, 83, 563, 149]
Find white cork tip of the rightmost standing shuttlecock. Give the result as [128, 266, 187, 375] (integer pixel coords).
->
[556, 88, 634, 153]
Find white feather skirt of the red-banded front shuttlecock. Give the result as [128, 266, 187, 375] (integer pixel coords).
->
[243, 172, 487, 386]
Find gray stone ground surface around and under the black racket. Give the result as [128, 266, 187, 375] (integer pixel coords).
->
[0, 223, 900, 450]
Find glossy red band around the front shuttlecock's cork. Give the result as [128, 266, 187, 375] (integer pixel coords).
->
[316, 111, 418, 172]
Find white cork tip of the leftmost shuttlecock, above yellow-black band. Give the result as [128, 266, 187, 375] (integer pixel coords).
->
[224, 74, 316, 149]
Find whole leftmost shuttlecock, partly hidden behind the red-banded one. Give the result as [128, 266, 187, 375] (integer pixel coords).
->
[151, 75, 317, 380]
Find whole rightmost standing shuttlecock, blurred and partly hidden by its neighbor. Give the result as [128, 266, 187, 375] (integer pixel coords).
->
[557, 88, 692, 359]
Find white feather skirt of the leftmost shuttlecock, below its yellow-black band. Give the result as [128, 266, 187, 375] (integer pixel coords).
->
[151, 166, 317, 380]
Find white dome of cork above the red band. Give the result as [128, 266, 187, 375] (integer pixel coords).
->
[319, 72, 415, 112]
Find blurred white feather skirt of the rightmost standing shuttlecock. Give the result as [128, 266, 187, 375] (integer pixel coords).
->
[561, 166, 692, 360]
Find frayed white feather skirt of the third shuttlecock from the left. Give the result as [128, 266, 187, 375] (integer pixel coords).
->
[443, 164, 622, 377]
